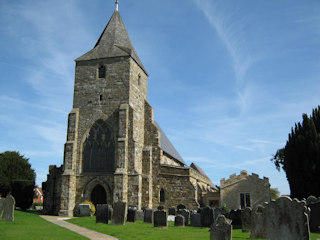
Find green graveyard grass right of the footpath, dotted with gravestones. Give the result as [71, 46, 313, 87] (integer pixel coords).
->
[67, 217, 320, 240]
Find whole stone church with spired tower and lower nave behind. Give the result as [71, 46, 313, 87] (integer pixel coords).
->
[43, 5, 218, 216]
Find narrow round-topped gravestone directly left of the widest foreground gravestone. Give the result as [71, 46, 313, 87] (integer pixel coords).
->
[250, 204, 266, 238]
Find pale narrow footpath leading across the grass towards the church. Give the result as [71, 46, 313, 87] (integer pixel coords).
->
[40, 215, 119, 240]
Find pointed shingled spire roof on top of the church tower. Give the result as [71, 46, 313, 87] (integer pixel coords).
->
[76, 10, 148, 75]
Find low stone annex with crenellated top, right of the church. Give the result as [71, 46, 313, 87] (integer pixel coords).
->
[220, 171, 270, 209]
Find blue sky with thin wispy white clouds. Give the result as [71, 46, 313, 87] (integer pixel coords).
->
[0, 0, 320, 194]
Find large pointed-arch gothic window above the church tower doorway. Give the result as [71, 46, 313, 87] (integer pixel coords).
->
[83, 120, 115, 173]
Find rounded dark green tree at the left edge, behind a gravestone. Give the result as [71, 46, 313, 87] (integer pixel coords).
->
[0, 151, 36, 209]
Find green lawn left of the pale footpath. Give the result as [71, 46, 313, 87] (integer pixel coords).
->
[0, 211, 88, 240]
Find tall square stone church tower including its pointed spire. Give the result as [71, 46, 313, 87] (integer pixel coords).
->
[59, 5, 148, 216]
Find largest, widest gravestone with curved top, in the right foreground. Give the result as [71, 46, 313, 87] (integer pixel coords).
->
[265, 197, 310, 240]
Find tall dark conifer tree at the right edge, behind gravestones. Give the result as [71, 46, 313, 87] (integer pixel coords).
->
[271, 106, 320, 199]
